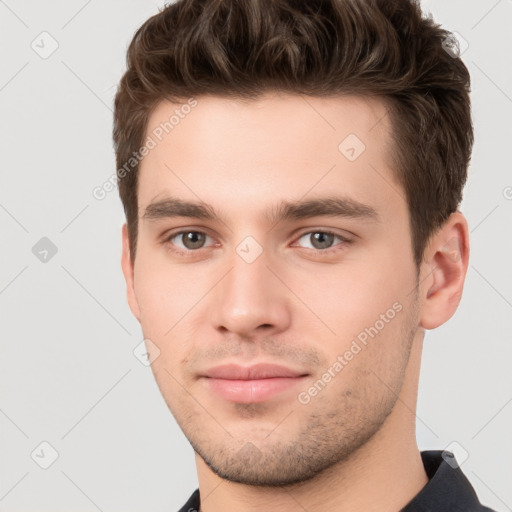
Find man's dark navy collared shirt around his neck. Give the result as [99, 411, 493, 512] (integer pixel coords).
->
[178, 450, 495, 512]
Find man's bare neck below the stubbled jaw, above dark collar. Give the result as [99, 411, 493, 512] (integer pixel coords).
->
[196, 339, 428, 512]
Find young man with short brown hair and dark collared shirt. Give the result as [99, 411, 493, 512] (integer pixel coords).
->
[114, 0, 498, 512]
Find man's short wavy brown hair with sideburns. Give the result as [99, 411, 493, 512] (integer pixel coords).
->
[113, 0, 473, 266]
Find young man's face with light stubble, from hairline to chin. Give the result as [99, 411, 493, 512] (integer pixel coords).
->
[124, 94, 423, 485]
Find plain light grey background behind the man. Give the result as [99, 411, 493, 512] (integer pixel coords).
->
[0, 0, 512, 512]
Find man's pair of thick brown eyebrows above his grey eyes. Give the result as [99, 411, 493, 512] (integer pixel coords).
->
[142, 197, 380, 224]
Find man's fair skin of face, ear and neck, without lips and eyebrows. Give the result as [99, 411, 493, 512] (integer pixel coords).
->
[122, 93, 469, 512]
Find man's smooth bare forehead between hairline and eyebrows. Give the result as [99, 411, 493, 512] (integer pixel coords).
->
[138, 93, 403, 221]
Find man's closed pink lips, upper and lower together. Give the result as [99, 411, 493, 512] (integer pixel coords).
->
[201, 363, 307, 404]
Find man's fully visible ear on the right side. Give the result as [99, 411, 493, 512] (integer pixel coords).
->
[420, 212, 469, 329]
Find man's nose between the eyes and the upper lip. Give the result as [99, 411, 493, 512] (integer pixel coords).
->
[212, 252, 291, 338]
